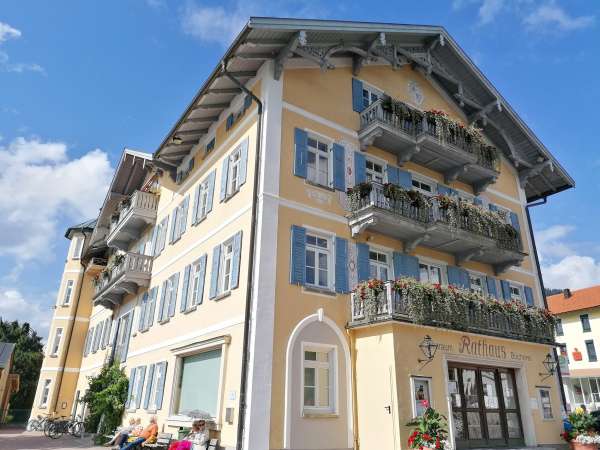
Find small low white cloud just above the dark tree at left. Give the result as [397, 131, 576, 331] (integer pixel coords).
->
[0, 288, 52, 337]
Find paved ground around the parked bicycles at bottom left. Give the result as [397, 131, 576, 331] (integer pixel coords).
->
[0, 428, 107, 450]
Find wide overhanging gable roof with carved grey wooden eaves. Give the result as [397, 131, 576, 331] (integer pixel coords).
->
[154, 17, 575, 201]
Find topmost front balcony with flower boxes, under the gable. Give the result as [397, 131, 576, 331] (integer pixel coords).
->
[358, 98, 500, 195]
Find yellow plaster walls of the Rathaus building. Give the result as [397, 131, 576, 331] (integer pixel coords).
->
[33, 19, 561, 450]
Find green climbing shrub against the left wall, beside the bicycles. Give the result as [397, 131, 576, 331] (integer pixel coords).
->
[82, 364, 129, 436]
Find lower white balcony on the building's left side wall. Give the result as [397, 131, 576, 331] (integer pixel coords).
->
[94, 252, 152, 308]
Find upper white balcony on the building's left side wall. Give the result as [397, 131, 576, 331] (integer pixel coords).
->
[106, 191, 158, 250]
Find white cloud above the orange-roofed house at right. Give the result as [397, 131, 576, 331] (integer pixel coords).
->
[535, 225, 600, 289]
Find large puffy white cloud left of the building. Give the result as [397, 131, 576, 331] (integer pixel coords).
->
[0, 137, 112, 265]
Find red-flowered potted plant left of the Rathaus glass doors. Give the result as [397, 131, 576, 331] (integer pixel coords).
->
[406, 400, 450, 450]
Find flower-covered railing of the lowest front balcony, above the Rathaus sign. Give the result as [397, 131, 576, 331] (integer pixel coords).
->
[350, 281, 554, 343]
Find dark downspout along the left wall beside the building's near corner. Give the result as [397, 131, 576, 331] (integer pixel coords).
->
[221, 61, 263, 450]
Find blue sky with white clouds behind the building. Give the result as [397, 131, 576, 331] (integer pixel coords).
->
[0, 0, 600, 333]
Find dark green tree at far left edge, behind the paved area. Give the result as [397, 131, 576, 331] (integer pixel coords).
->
[0, 318, 44, 409]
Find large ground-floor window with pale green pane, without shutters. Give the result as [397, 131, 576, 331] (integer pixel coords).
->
[174, 348, 222, 417]
